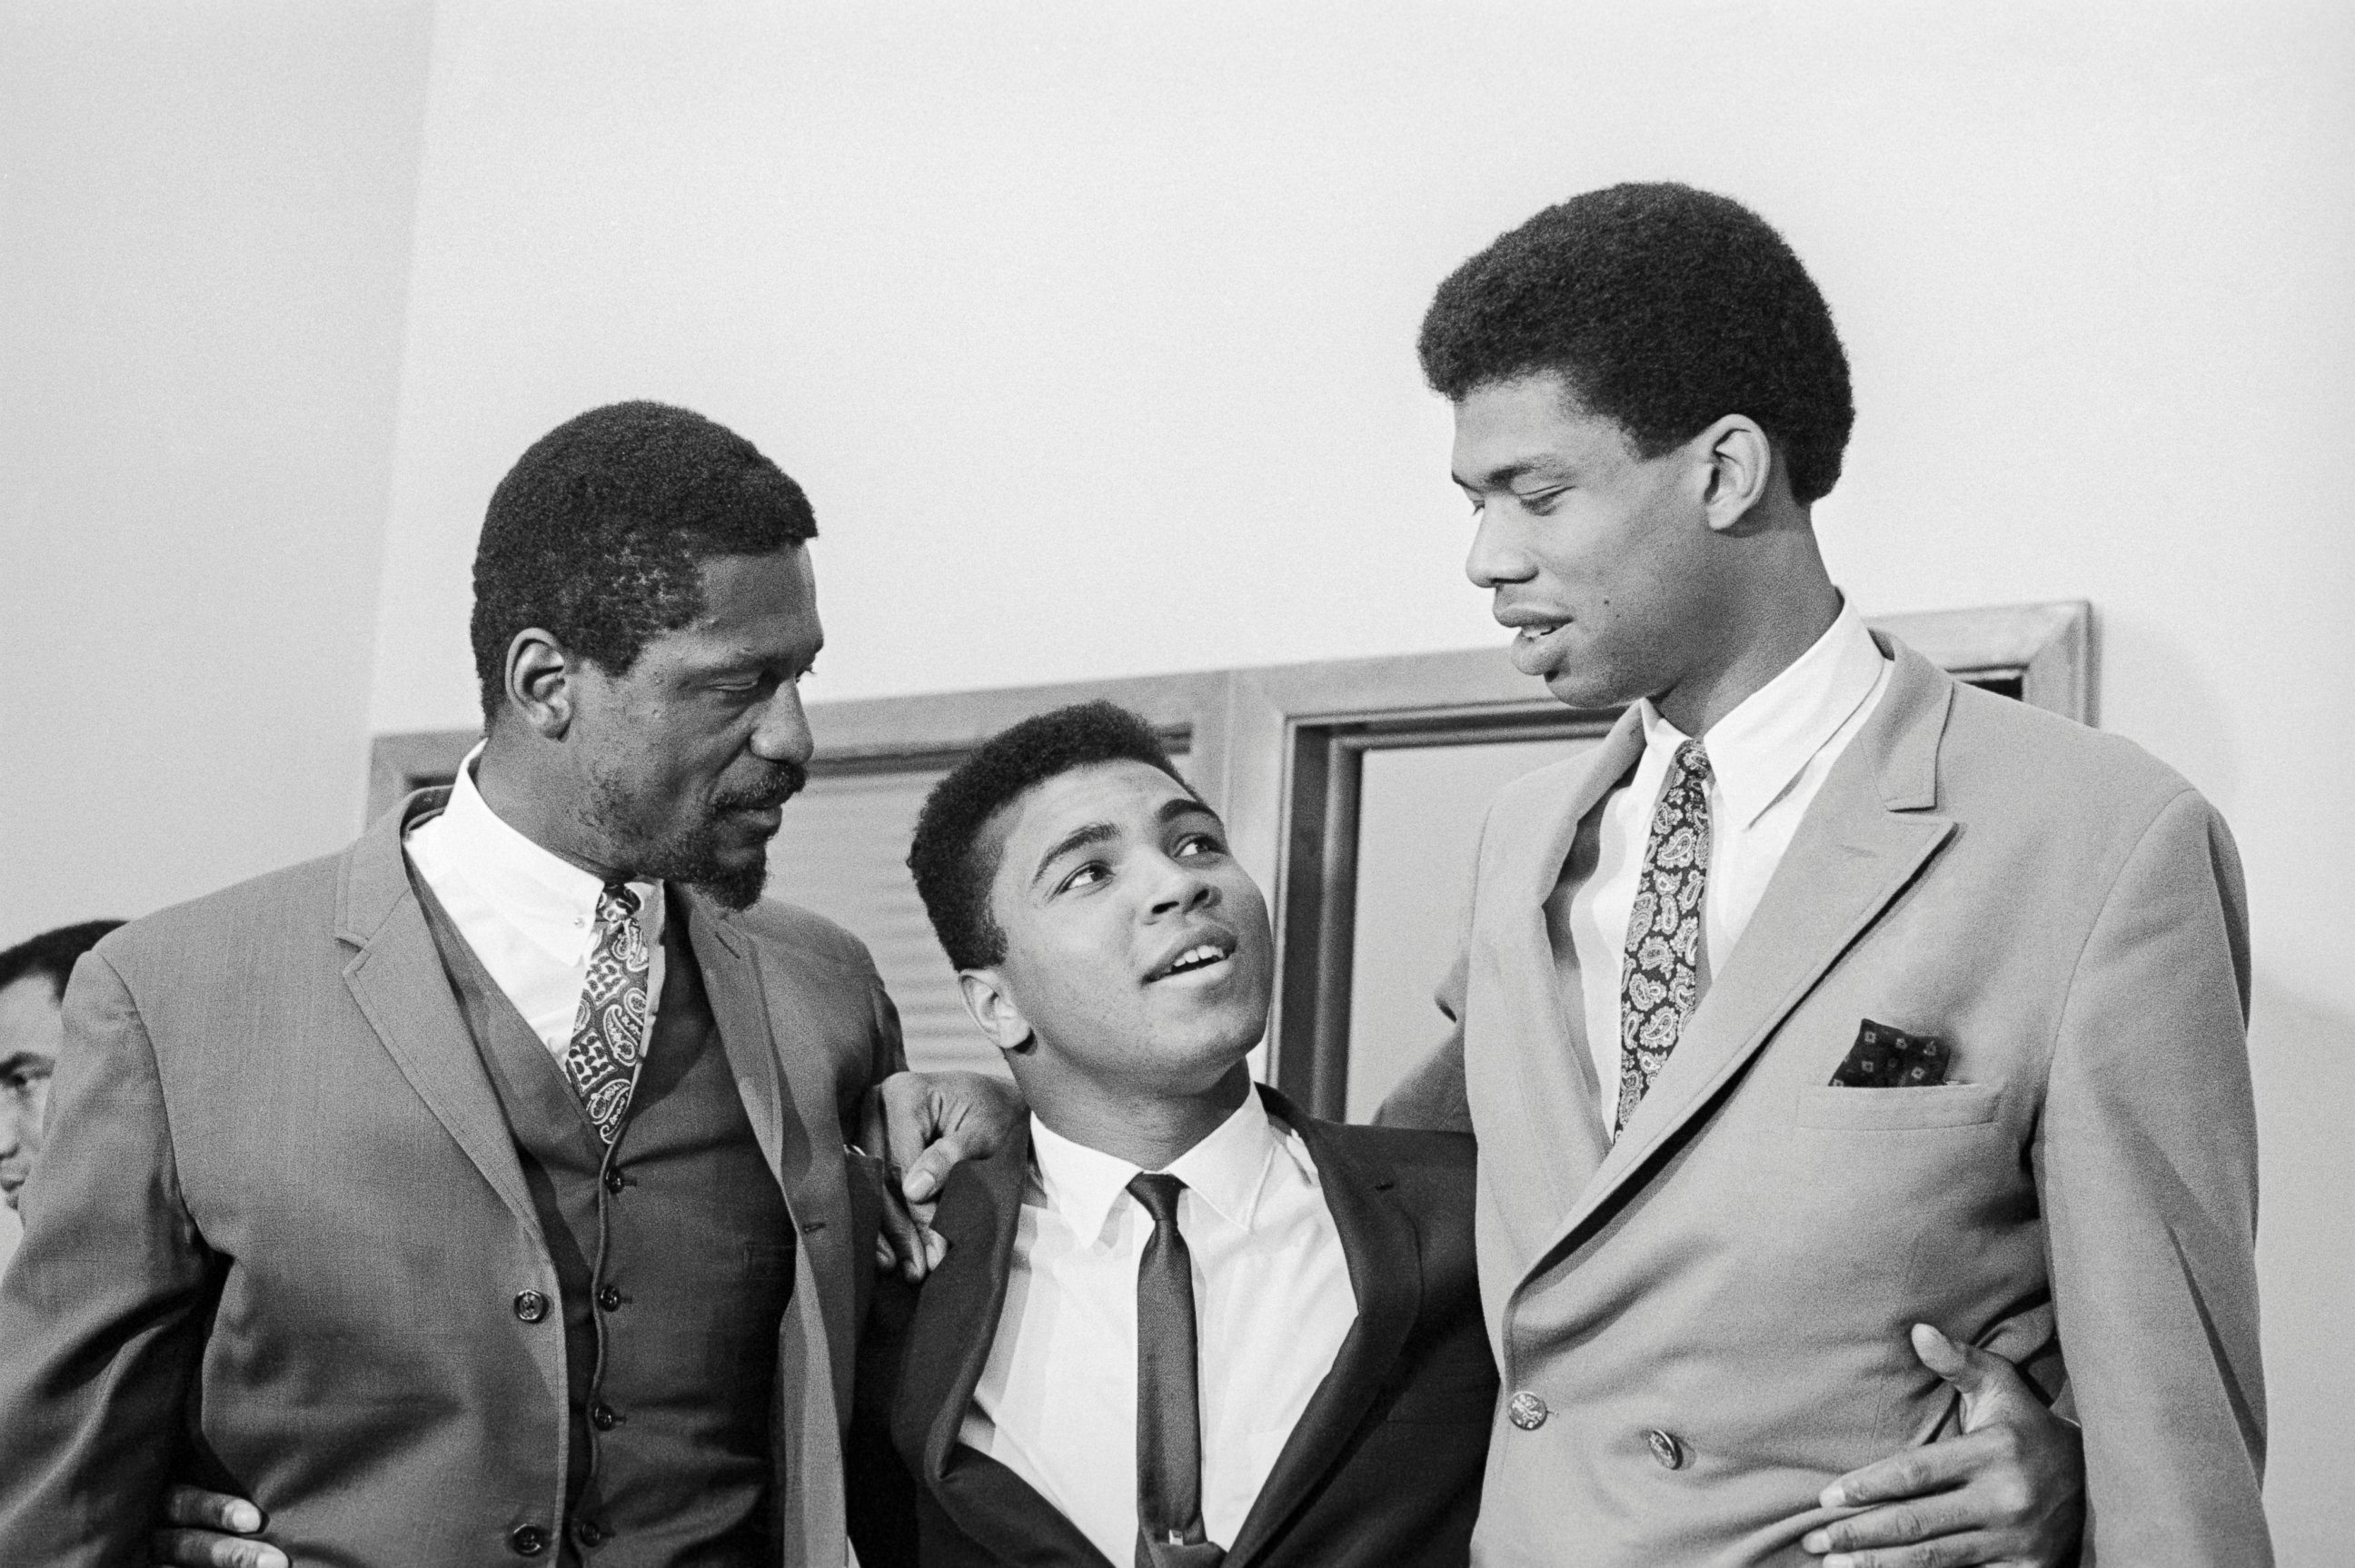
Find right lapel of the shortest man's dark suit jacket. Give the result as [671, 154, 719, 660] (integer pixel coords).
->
[1227, 1087, 1423, 1568]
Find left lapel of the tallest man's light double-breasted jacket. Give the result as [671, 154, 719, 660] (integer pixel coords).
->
[1484, 709, 1644, 1215]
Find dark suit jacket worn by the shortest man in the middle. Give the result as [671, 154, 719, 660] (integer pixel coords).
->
[852, 1090, 1495, 1568]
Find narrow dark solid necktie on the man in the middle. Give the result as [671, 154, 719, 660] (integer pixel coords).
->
[1128, 1173, 1227, 1568]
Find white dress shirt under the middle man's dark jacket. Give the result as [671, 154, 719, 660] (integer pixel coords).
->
[959, 1092, 1356, 1563]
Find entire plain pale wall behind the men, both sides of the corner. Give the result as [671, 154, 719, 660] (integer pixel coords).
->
[0, 0, 2355, 1565]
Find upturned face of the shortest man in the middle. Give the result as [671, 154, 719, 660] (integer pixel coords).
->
[982, 760, 1274, 1095]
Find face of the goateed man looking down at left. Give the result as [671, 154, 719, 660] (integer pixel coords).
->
[572, 546, 824, 908]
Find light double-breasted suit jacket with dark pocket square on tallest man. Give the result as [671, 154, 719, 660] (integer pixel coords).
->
[1385, 638, 2271, 1568]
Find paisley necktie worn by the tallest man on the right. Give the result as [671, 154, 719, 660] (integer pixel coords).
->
[1611, 739, 1710, 1137]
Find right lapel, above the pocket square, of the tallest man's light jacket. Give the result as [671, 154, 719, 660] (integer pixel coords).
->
[1540, 640, 1954, 1266]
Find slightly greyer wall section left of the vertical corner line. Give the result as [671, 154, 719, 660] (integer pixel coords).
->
[0, 0, 433, 928]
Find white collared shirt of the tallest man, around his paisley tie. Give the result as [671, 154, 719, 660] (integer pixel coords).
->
[1568, 602, 1891, 1123]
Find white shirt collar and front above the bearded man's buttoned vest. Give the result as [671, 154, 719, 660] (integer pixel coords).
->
[401, 744, 661, 1062]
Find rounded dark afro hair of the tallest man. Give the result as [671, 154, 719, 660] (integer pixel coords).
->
[1417, 184, 1855, 506]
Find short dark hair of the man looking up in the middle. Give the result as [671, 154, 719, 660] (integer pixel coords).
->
[907, 701, 1194, 970]
